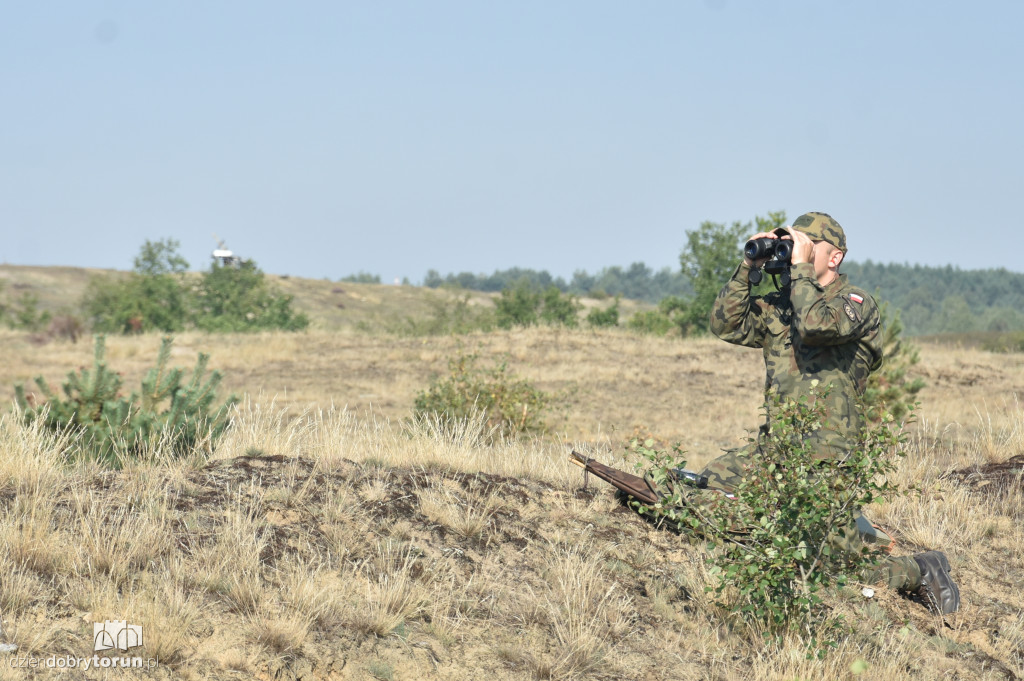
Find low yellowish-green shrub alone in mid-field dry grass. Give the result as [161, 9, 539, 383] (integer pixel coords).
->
[414, 352, 553, 437]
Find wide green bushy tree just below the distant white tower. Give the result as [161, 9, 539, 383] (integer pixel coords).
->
[193, 260, 309, 332]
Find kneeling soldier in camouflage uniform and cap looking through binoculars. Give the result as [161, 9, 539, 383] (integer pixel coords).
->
[693, 213, 959, 613]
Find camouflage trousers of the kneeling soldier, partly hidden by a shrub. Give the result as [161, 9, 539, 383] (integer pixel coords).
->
[687, 443, 921, 591]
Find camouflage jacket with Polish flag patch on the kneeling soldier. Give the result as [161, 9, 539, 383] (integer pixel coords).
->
[711, 263, 882, 458]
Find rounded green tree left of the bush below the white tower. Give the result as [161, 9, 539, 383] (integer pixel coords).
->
[82, 239, 189, 334]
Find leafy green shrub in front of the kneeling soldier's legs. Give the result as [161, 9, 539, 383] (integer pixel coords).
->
[635, 390, 901, 652]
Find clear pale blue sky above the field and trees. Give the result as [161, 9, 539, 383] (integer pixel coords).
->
[0, 0, 1024, 282]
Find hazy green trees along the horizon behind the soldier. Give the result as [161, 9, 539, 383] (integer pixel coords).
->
[399, 218, 1024, 336]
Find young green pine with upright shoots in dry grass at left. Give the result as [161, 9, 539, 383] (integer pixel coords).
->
[14, 336, 238, 467]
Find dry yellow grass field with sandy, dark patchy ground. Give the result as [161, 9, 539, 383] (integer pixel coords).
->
[0, 329, 1024, 681]
